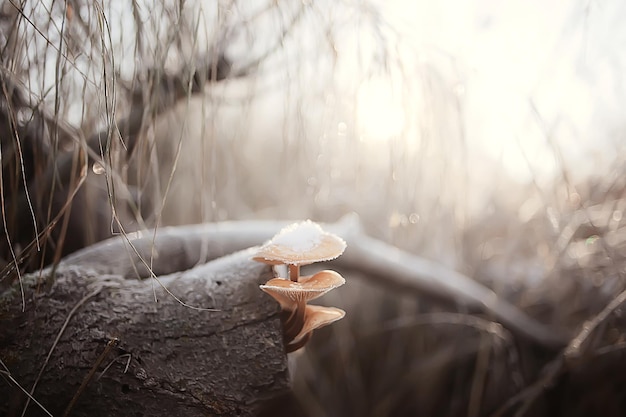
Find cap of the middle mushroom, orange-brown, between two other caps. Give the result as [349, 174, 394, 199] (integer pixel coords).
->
[260, 270, 346, 310]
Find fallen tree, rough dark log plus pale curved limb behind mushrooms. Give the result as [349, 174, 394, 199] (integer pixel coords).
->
[0, 214, 567, 416]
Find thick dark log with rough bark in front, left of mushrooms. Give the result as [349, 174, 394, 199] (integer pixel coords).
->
[0, 251, 288, 416]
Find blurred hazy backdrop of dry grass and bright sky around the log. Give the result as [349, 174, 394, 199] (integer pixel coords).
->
[0, 0, 626, 416]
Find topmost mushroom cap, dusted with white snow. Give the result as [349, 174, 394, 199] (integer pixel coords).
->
[252, 220, 346, 265]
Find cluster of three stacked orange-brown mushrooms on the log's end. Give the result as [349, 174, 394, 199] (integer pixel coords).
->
[253, 220, 346, 353]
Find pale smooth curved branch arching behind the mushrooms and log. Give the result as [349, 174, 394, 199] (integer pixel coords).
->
[57, 216, 570, 349]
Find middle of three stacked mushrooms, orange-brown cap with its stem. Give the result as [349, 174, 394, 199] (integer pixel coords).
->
[260, 270, 346, 342]
